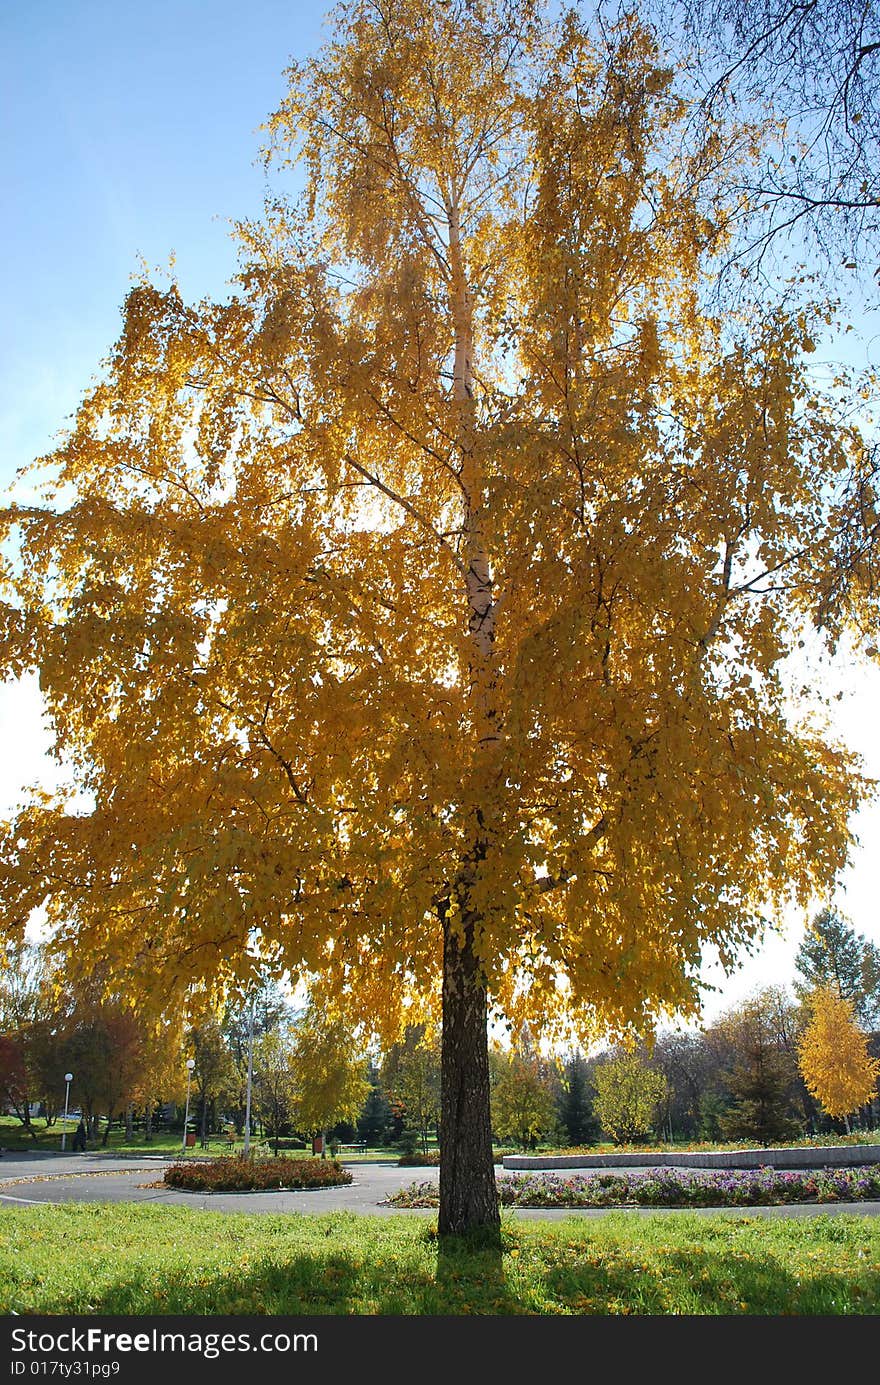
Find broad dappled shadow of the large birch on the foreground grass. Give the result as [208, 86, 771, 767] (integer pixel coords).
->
[10, 1228, 880, 1317]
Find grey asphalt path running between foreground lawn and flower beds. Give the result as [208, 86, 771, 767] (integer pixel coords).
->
[0, 1152, 880, 1222]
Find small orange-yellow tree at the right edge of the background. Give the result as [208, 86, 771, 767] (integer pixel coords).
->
[800, 986, 880, 1133]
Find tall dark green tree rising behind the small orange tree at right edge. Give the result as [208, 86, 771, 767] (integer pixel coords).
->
[794, 906, 880, 1029]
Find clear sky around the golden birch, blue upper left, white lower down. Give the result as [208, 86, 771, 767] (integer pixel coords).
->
[0, 0, 880, 1030]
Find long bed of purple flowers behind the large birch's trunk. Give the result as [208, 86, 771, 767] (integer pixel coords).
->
[388, 1165, 880, 1208]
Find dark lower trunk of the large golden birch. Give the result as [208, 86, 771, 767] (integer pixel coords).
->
[438, 920, 500, 1237]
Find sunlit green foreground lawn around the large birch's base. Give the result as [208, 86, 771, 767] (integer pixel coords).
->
[0, 1204, 880, 1316]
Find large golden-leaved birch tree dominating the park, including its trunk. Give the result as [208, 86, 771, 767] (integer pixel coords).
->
[1, 0, 861, 1233]
